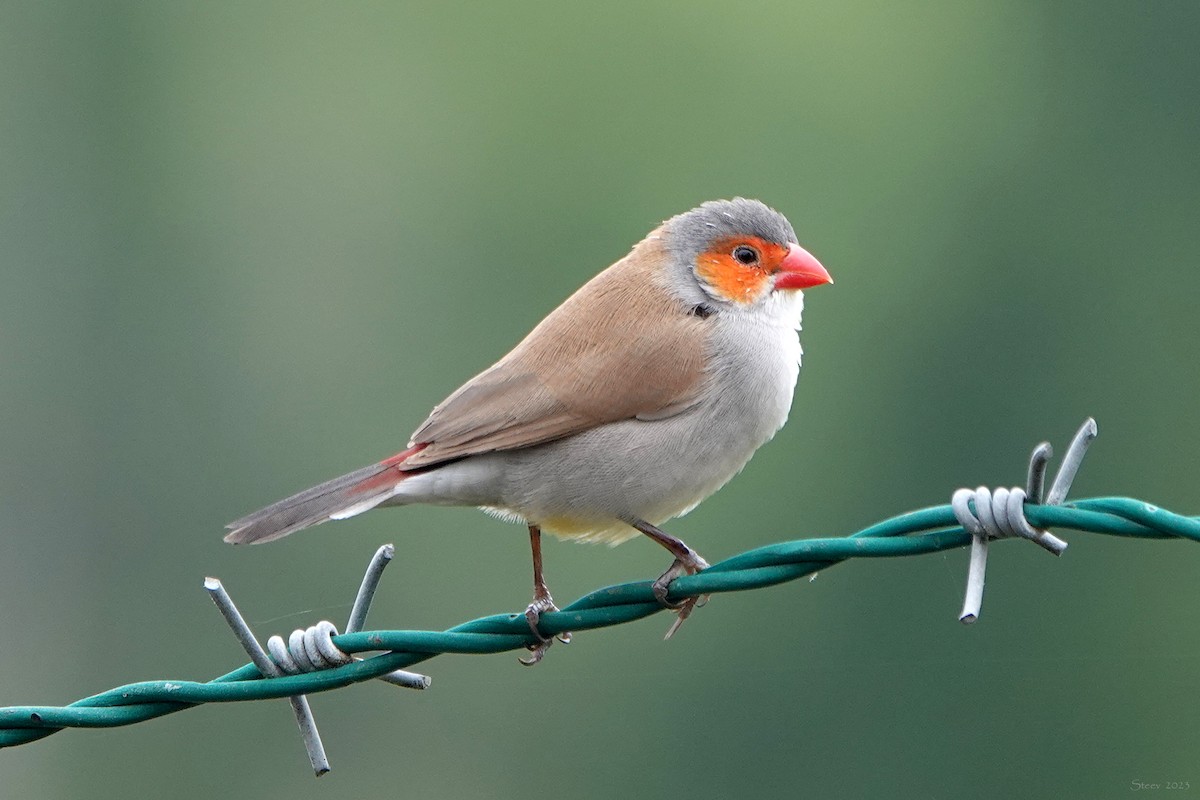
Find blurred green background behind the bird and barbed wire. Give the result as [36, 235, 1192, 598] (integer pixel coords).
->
[0, 0, 1200, 799]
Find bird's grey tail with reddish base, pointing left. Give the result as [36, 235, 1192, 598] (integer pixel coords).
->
[224, 445, 425, 545]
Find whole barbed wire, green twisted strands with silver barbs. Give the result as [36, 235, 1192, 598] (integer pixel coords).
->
[0, 420, 1200, 775]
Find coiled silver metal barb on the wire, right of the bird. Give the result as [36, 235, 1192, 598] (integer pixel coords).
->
[950, 417, 1097, 625]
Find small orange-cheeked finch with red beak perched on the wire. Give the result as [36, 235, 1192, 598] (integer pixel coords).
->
[224, 198, 833, 663]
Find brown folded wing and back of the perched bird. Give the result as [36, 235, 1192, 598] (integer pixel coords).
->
[403, 235, 707, 469]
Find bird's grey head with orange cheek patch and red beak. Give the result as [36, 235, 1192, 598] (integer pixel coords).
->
[662, 198, 833, 307]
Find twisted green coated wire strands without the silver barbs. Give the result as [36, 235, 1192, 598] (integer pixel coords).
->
[0, 498, 1200, 747]
